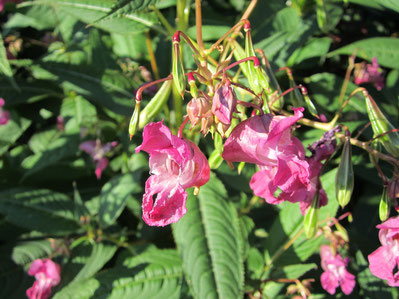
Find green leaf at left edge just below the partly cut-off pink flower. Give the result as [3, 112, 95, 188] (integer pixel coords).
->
[0, 114, 31, 155]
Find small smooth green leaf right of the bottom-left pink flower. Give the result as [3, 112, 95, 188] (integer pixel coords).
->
[73, 242, 118, 282]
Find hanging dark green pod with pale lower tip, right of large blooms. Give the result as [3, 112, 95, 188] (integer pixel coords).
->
[335, 137, 354, 208]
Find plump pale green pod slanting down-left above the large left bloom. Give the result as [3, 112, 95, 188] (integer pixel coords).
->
[139, 80, 172, 129]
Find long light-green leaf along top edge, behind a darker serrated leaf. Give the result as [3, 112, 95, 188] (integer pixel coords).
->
[20, 0, 164, 34]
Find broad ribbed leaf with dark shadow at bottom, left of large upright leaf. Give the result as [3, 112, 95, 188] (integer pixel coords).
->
[53, 249, 183, 299]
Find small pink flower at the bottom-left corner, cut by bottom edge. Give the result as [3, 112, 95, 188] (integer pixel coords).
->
[26, 259, 61, 299]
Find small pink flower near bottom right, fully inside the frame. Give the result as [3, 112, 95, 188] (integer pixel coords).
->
[320, 245, 356, 295]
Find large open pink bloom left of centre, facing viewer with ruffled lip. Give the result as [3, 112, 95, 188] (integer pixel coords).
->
[136, 122, 210, 226]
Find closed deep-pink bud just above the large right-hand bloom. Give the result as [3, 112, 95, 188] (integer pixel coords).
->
[212, 79, 237, 125]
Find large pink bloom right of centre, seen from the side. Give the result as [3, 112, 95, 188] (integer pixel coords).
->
[223, 108, 311, 209]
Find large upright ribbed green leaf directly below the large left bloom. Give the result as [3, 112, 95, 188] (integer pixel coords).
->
[172, 175, 244, 298]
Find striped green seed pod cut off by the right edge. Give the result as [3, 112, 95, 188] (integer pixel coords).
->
[365, 95, 399, 158]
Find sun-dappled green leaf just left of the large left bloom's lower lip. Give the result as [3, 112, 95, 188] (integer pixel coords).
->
[98, 171, 142, 227]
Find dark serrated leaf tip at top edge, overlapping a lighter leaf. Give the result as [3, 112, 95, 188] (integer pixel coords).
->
[94, 0, 158, 24]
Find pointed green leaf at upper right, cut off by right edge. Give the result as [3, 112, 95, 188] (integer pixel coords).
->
[327, 37, 399, 69]
